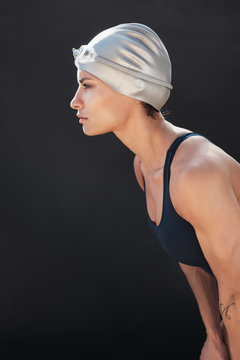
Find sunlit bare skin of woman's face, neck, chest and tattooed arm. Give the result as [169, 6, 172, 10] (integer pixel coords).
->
[71, 70, 240, 360]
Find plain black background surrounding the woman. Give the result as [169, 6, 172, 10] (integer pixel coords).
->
[0, 0, 240, 360]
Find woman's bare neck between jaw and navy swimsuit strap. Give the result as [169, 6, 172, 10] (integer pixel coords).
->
[113, 112, 186, 175]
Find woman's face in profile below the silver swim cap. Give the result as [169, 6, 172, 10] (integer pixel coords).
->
[70, 70, 139, 135]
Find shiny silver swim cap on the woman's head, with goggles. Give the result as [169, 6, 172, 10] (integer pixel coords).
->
[73, 23, 173, 111]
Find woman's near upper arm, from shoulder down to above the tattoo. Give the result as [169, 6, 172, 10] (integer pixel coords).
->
[175, 164, 240, 281]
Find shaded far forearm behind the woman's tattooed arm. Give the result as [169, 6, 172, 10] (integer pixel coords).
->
[179, 263, 222, 341]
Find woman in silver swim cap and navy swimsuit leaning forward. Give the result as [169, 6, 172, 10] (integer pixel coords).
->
[71, 23, 240, 360]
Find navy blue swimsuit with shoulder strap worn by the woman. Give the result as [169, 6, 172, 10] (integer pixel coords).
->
[143, 132, 215, 277]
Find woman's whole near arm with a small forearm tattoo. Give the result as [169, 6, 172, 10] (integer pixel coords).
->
[177, 164, 240, 360]
